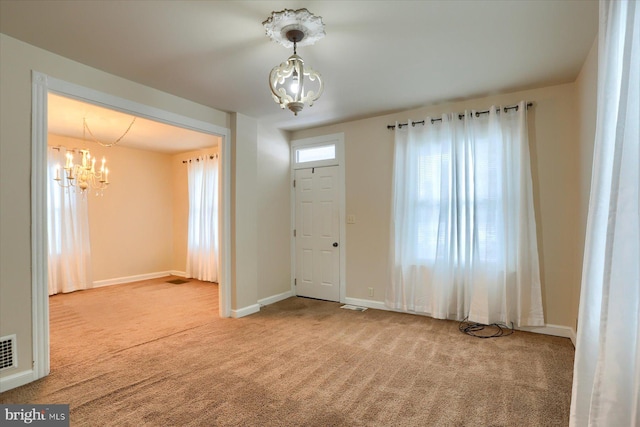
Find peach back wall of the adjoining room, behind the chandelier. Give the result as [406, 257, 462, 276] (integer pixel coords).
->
[48, 134, 173, 284]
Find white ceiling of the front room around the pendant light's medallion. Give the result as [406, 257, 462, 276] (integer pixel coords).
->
[0, 0, 598, 150]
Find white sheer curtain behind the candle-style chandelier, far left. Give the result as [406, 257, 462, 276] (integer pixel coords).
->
[47, 147, 92, 295]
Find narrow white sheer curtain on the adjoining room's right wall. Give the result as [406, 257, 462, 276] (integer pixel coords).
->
[186, 156, 218, 282]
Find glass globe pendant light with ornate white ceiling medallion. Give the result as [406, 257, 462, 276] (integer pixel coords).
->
[262, 9, 325, 116]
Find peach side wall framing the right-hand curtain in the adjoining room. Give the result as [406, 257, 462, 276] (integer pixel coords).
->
[171, 146, 222, 273]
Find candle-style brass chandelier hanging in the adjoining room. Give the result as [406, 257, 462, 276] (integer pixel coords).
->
[53, 150, 109, 193]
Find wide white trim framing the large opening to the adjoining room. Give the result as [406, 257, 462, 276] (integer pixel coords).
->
[31, 71, 231, 380]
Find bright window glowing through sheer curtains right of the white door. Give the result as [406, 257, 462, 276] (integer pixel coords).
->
[409, 130, 508, 266]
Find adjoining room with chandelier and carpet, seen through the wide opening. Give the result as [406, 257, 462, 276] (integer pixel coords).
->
[47, 93, 224, 371]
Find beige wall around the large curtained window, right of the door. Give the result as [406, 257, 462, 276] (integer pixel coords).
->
[291, 84, 582, 327]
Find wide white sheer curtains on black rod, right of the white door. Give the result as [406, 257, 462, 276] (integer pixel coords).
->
[386, 102, 544, 326]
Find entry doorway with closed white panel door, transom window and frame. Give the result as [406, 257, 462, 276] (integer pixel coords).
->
[291, 133, 346, 302]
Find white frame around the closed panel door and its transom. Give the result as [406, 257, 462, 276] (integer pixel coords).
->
[290, 133, 347, 303]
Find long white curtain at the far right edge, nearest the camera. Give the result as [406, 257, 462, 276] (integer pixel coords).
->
[570, 0, 640, 427]
